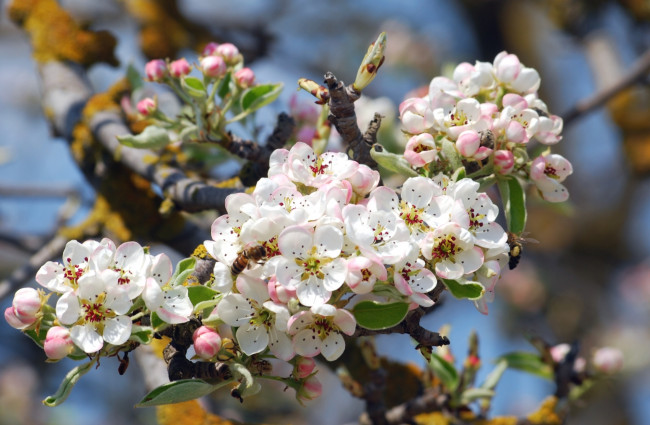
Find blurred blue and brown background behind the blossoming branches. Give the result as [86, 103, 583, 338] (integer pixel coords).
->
[0, 0, 650, 425]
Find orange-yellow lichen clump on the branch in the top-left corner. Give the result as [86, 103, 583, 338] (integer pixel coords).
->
[8, 0, 119, 66]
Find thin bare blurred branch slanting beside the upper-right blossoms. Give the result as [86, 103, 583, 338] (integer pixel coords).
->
[562, 50, 650, 126]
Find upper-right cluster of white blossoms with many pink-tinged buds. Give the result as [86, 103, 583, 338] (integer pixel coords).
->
[399, 52, 573, 202]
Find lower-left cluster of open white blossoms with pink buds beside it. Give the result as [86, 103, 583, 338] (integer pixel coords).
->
[5, 238, 192, 359]
